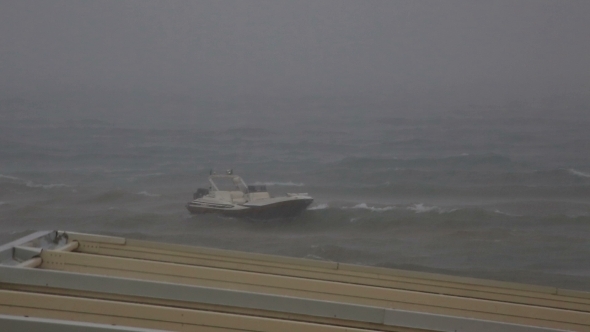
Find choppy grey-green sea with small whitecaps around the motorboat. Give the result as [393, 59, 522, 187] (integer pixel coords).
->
[0, 100, 590, 291]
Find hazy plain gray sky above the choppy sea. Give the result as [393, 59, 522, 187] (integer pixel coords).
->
[0, 0, 590, 104]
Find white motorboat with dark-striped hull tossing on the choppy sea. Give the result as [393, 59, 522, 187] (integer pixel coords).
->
[186, 171, 313, 219]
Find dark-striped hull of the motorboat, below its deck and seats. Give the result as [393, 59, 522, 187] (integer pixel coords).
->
[186, 199, 313, 219]
